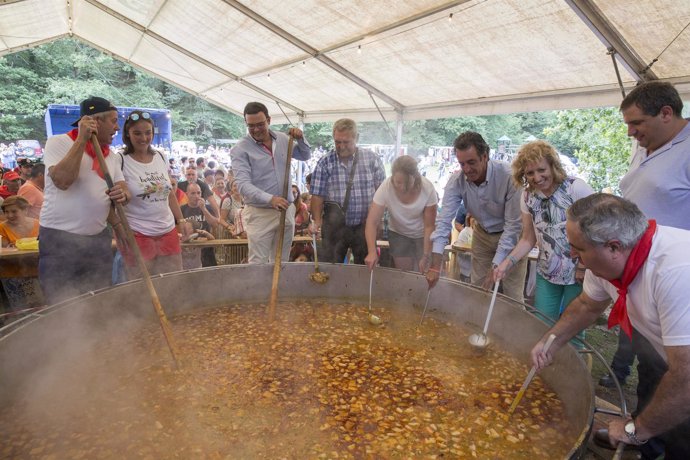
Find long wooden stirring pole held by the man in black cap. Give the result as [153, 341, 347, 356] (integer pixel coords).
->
[91, 134, 180, 368]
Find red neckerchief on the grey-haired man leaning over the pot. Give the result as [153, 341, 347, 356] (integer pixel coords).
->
[609, 219, 656, 339]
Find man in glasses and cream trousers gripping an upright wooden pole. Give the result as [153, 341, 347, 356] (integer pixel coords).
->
[230, 102, 311, 264]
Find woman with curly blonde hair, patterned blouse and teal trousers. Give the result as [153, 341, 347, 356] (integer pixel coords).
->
[494, 141, 594, 330]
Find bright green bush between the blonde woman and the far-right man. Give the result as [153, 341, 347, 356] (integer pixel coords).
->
[546, 107, 631, 194]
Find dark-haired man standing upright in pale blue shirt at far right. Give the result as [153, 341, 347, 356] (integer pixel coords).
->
[594, 80, 690, 459]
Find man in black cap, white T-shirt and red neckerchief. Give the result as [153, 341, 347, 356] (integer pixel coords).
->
[38, 97, 130, 304]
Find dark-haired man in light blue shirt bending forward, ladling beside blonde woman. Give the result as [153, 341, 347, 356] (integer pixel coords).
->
[427, 131, 527, 302]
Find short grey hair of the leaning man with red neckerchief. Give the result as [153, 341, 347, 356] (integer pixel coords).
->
[568, 193, 648, 249]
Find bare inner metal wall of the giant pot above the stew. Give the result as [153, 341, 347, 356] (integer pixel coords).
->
[0, 263, 594, 458]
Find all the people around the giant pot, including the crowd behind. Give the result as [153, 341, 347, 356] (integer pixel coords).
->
[0, 82, 690, 459]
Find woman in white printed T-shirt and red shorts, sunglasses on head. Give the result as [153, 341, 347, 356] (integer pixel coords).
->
[113, 110, 189, 278]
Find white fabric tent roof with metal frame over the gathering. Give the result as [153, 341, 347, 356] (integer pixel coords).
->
[0, 0, 690, 123]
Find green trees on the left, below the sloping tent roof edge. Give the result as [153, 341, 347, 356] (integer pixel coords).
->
[0, 39, 245, 144]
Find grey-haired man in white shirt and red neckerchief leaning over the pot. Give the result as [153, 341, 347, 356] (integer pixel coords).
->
[532, 193, 690, 460]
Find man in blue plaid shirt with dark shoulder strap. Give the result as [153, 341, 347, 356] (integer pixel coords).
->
[310, 118, 386, 264]
